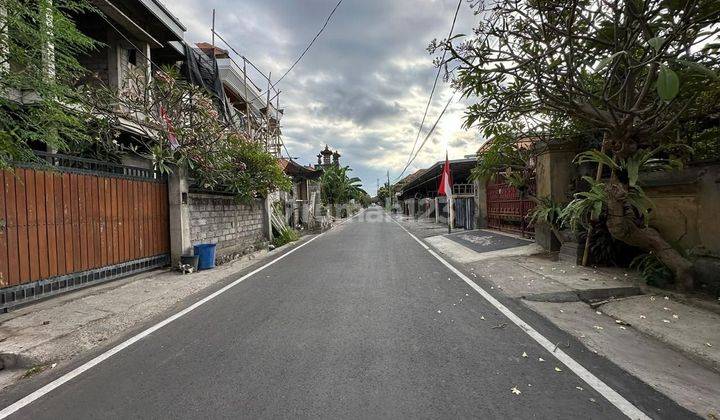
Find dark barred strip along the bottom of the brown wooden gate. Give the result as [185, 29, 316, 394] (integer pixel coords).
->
[0, 254, 170, 312]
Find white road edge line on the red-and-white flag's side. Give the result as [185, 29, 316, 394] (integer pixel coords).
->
[392, 219, 650, 420]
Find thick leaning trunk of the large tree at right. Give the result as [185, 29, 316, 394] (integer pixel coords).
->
[607, 174, 695, 291]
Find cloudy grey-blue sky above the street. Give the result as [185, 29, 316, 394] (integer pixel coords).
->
[165, 0, 480, 194]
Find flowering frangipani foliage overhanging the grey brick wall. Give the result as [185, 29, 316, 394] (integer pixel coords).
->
[88, 67, 291, 201]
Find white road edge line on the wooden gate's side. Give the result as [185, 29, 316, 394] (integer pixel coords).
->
[0, 210, 365, 420]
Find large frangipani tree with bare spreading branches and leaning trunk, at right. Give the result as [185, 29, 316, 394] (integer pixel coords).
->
[431, 0, 720, 288]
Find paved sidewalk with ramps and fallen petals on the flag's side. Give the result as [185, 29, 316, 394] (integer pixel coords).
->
[396, 216, 720, 418]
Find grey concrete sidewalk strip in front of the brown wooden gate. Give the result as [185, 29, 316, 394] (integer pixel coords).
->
[0, 237, 309, 390]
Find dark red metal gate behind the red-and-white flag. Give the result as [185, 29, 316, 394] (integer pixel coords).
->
[486, 180, 535, 238]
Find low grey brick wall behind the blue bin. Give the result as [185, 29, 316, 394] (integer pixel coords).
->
[189, 193, 267, 254]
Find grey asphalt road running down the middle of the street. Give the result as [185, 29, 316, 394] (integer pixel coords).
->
[1, 209, 689, 419]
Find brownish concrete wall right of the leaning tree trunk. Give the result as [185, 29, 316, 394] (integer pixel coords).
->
[641, 163, 720, 257]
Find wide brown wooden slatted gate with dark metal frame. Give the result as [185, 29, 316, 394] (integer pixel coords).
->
[0, 155, 169, 309]
